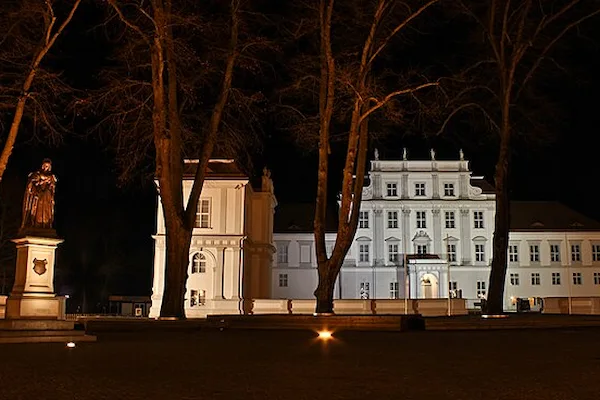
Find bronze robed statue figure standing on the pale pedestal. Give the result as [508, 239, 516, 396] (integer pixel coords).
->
[21, 158, 56, 232]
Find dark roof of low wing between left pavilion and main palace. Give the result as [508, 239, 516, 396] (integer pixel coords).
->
[273, 203, 338, 233]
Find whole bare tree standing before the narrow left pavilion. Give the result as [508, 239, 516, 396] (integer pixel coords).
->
[97, 0, 265, 318]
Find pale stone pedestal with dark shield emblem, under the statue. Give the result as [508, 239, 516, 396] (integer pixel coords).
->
[6, 236, 64, 319]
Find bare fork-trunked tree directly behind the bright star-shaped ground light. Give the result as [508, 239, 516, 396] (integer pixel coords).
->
[278, 0, 438, 313]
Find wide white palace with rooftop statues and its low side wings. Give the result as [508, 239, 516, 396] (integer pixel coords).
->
[272, 151, 600, 309]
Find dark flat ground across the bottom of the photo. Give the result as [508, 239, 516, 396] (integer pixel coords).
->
[0, 328, 600, 400]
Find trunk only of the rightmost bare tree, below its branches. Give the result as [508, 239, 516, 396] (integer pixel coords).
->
[484, 101, 511, 314]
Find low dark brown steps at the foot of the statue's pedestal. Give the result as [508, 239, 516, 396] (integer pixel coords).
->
[0, 319, 96, 343]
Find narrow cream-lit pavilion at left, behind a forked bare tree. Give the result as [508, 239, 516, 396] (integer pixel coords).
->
[150, 159, 277, 318]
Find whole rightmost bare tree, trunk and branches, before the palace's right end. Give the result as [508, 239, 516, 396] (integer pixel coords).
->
[442, 0, 600, 313]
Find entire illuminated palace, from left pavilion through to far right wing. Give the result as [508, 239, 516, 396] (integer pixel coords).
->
[150, 155, 600, 318]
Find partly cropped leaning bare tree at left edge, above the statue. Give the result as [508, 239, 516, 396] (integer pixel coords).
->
[0, 0, 81, 181]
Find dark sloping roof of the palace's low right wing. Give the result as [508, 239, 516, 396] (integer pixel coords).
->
[510, 201, 600, 232]
